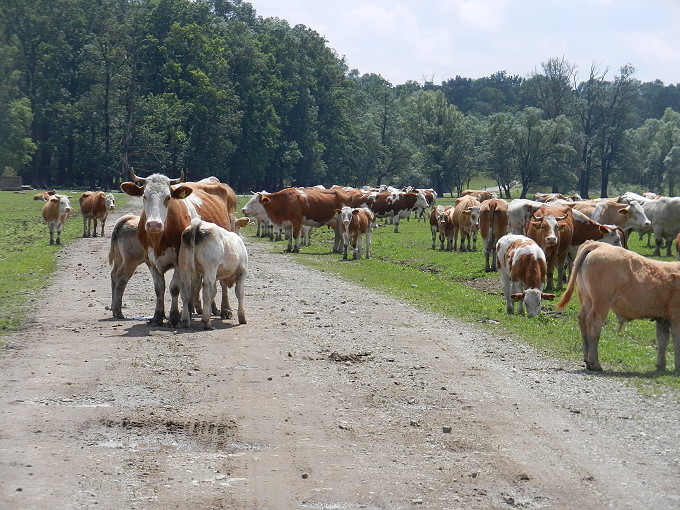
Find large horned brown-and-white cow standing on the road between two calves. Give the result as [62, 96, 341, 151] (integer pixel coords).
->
[121, 168, 233, 326]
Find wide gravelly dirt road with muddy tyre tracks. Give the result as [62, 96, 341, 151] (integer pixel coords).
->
[0, 200, 680, 510]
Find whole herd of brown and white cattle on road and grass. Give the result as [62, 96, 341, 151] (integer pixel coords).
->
[35, 177, 680, 370]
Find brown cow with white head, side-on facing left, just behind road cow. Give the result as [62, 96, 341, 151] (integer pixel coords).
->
[241, 188, 351, 253]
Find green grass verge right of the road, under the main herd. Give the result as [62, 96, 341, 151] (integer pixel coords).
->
[239, 199, 680, 395]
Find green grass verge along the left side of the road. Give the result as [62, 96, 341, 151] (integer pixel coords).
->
[0, 190, 127, 338]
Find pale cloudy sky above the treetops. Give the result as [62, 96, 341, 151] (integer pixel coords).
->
[247, 0, 680, 85]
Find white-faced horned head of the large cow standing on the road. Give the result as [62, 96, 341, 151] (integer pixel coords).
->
[120, 168, 192, 234]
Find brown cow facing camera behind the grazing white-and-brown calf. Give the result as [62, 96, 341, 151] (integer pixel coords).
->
[526, 204, 574, 291]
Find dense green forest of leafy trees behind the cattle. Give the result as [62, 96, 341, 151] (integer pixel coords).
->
[0, 0, 680, 197]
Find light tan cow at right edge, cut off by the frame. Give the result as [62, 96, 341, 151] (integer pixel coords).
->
[557, 241, 680, 372]
